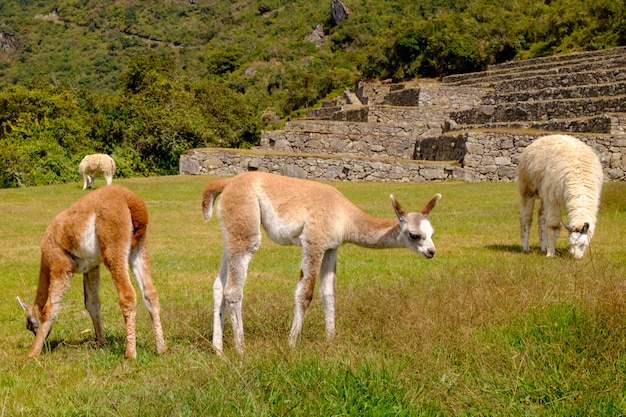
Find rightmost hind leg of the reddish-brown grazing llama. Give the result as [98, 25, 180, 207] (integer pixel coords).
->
[130, 243, 167, 353]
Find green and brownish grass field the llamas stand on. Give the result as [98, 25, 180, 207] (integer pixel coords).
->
[0, 176, 626, 416]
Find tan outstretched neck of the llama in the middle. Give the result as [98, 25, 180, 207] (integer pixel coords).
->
[345, 211, 404, 248]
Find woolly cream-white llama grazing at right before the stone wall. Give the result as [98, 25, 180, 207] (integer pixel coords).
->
[518, 135, 603, 259]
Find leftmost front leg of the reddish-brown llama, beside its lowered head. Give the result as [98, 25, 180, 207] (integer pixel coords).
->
[28, 266, 72, 358]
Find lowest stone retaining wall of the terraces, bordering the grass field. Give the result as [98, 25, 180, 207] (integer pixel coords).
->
[180, 131, 626, 182]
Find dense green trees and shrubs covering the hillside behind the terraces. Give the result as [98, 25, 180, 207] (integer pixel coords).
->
[0, 0, 626, 187]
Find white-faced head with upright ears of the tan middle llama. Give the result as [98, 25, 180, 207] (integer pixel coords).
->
[389, 194, 441, 259]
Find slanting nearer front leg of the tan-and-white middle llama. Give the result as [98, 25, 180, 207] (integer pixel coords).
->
[288, 244, 324, 347]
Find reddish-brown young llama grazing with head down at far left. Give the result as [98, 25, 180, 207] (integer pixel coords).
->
[17, 185, 167, 359]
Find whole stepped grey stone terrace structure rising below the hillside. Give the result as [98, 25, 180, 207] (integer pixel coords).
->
[180, 48, 626, 181]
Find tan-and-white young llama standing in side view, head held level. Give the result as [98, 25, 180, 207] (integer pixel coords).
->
[202, 172, 441, 354]
